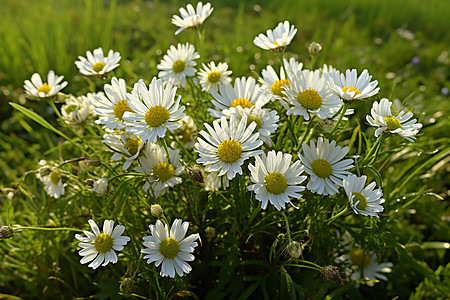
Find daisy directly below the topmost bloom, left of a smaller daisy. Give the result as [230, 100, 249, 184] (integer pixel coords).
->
[157, 43, 200, 88]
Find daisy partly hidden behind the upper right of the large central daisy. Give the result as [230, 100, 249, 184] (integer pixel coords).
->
[230, 106, 280, 147]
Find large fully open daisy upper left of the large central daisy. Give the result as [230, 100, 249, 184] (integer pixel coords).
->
[122, 78, 186, 143]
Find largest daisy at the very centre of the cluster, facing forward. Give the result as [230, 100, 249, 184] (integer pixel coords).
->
[195, 115, 263, 180]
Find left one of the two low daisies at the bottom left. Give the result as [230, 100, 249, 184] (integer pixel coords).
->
[75, 220, 130, 270]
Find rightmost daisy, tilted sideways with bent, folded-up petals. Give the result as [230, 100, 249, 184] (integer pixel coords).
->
[366, 98, 422, 142]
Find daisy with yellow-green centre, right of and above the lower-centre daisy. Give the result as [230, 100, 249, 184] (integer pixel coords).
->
[298, 137, 353, 196]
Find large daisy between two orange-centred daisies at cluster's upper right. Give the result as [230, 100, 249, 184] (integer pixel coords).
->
[285, 70, 342, 121]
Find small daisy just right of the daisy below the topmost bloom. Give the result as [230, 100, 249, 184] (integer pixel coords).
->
[198, 61, 232, 92]
